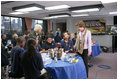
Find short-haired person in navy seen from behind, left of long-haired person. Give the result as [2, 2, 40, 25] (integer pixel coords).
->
[9, 37, 25, 78]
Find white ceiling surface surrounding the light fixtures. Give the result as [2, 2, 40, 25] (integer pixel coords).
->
[1, 1, 117, 19]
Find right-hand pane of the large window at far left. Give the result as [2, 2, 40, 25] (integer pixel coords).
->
[11, 17, 22, 34]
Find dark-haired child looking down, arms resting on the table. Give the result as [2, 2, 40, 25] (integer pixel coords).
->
[40, 35, 56, 53]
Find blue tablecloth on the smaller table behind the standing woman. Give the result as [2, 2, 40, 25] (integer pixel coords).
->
[91, 42, 102, 57]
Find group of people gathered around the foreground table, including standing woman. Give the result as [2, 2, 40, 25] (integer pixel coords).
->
[2, 21, 91, 79]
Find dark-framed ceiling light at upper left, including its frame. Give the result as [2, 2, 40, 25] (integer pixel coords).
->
[12, 4, 44, 12]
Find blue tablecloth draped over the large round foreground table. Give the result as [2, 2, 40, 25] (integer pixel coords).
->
[45, 57, 87, 79]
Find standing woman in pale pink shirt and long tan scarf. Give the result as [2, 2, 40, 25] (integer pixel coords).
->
[75, 21, 92, 77]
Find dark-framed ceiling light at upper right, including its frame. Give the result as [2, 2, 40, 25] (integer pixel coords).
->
[69, 4, 104, 13]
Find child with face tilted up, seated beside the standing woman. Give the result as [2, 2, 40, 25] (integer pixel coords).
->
[61, 32, 73, 53]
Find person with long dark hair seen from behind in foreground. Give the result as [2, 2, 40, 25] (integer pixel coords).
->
[22, 39, 44, 79]
